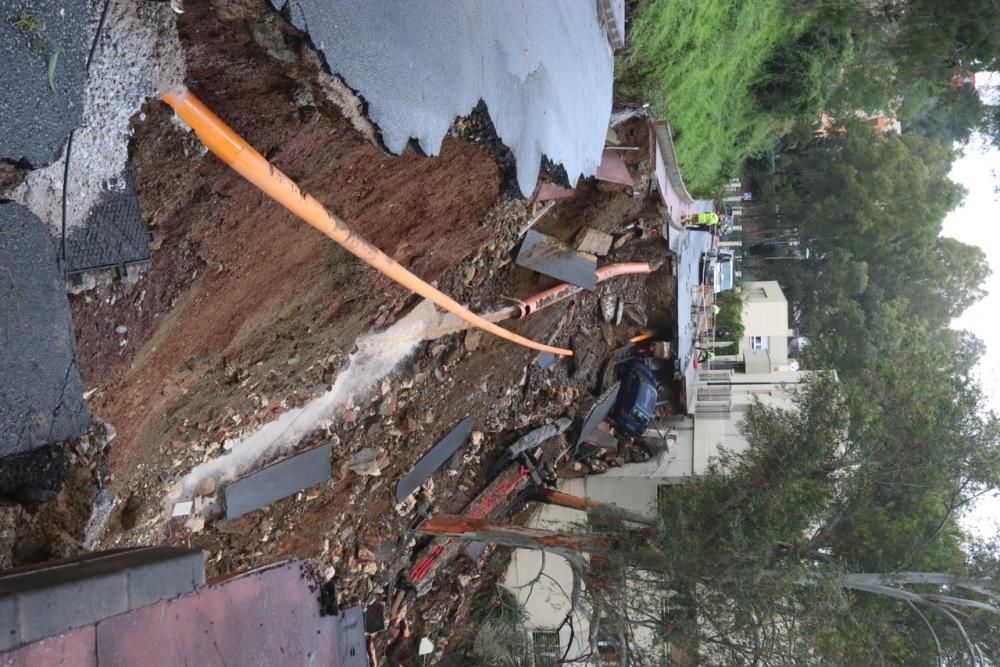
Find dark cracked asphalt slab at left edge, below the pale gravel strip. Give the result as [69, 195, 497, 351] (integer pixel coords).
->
[0, 204, 90, 464]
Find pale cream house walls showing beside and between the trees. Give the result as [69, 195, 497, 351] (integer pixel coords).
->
[505, 281, 824, 664]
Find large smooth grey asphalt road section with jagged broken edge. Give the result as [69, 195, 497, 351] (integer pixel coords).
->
[274, 0, 614, 195]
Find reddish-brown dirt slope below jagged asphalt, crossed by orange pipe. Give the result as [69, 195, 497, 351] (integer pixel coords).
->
[73, 2, 499, 468]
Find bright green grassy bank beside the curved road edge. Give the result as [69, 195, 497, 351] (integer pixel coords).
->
[618, 0, 810, 194]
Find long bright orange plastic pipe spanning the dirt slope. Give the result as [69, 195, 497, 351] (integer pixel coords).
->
[163, 89, 573, 356]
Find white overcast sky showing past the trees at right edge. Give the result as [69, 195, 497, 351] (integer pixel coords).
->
[943, 74, 1000, 537]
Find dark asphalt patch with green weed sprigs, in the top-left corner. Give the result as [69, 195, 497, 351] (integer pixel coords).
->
[0, 0, 89, 167]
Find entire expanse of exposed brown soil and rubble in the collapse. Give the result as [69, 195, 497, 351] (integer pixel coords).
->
[23, 0, 675, 664]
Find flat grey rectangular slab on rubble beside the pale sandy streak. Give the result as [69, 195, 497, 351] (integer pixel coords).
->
[226, 442, 333, 519]
